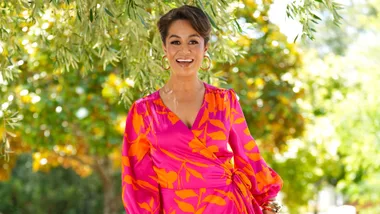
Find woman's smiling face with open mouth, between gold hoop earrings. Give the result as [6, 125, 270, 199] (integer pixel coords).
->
[163, 20, 208, 76]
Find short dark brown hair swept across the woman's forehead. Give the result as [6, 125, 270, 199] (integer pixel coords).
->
[157, 5, 211, 45]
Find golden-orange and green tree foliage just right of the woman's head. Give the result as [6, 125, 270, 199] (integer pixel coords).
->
[215, 1, 305, 152]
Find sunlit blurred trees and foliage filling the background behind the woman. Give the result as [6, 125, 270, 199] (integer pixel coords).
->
[0, 0, 380, 214]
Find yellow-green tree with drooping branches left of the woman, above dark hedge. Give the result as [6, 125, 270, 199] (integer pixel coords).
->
[0, 0, 252, 213]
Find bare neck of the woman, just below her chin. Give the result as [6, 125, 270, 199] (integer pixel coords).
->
[164, 76, 203, 92]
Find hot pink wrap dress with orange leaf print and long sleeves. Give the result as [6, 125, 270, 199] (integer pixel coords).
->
[122, 83, 282, 214]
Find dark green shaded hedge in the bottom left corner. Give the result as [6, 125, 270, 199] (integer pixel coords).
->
[0, 154, 103, 214]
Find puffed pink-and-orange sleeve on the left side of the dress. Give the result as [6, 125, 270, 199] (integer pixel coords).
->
[122, 103, 160, 214]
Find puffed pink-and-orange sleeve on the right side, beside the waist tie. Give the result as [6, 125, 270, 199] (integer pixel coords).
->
[228, 89, 282, 206]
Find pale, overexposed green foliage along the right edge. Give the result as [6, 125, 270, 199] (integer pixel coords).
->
[276, 0, 380, 213]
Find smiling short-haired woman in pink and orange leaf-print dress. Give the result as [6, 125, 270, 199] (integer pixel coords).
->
[122, 6, 282, 214]
